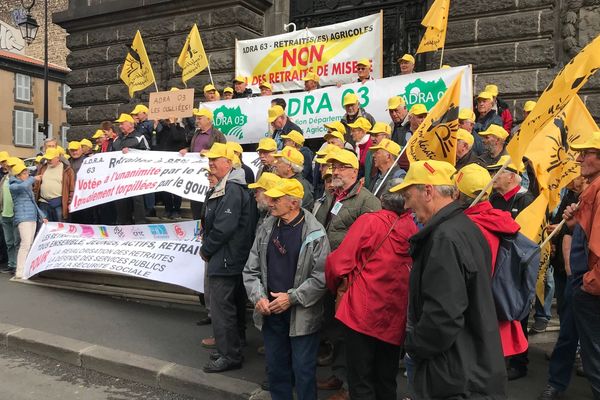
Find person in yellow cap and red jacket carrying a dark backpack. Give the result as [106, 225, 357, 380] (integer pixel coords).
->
[455, 164, 528, 357]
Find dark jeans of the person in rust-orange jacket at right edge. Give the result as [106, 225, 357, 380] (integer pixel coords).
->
[573, 287, 600, 400]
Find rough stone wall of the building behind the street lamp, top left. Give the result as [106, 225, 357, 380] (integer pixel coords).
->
[0, 0, 69, 67]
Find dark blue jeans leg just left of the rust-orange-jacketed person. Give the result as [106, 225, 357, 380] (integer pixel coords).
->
[548, 277, 579, 392]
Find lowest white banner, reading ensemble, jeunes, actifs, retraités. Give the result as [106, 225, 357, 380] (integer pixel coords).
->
[23, 221, 204, 293]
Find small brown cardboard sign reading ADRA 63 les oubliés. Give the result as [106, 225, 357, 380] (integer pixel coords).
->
[148, 89, 194, 119]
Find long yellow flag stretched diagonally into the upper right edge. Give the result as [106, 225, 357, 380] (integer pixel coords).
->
[506, 35, 600, 166]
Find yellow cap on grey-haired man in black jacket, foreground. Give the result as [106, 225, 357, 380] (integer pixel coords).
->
[390, 160, 456, 192]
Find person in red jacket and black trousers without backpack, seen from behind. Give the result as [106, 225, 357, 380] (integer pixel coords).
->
[325, 179, 417, 399]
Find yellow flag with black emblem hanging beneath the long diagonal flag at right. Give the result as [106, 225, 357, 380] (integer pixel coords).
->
[525, 95, 600, 210]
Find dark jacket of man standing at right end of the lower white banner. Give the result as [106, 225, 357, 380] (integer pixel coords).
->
[200, 169, 258, 276]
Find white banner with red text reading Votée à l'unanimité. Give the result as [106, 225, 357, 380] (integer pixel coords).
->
[69, 150, 260, 212]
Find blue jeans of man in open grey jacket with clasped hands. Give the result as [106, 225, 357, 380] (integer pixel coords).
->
[262, 310, 319, 400]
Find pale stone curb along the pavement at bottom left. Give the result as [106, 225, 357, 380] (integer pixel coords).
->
[0, 323, 259, 400]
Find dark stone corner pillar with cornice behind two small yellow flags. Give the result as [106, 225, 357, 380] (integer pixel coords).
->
[53, 0, 272, 139]
